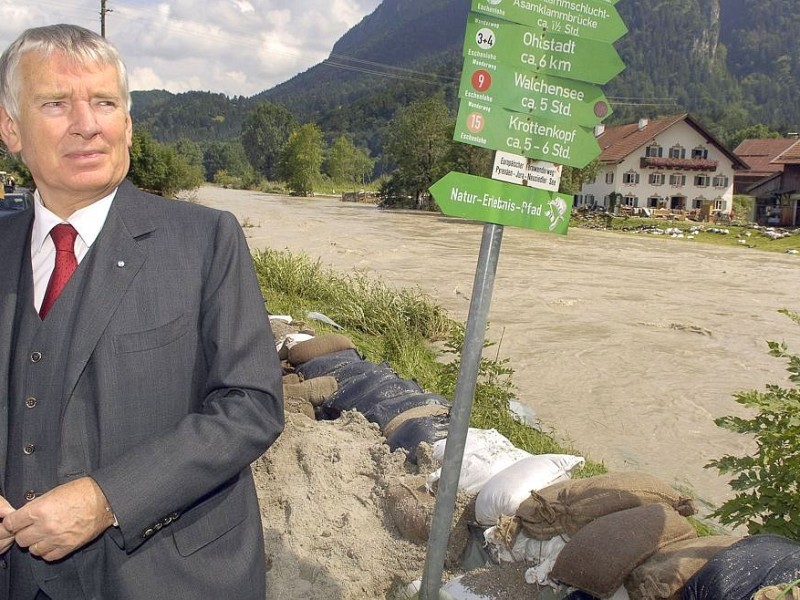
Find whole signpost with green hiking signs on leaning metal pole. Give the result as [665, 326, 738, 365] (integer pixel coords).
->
[420, 0, 627, 600]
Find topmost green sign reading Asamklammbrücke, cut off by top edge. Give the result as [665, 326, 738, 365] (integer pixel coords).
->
[472, 0, 628, 43]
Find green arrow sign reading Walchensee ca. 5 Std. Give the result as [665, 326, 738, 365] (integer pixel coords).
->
[459, 58, 613, 127]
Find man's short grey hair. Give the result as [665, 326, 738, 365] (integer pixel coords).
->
[0, 24, 131, 121]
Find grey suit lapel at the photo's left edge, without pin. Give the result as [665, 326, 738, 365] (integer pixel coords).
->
[0, 210, 33, 488]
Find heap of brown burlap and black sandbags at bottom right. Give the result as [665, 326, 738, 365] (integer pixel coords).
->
[476, 473, 800, 600]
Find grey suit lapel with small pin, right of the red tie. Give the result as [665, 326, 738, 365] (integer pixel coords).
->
[64, 182, 155, 407]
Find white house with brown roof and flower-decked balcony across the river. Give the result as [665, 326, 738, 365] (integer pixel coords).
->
[575, 114, 748, 218]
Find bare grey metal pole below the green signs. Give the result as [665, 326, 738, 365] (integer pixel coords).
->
[419, 223, 503, 600]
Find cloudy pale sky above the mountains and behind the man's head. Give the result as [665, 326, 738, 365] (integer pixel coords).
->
[0, 0, 381, 96]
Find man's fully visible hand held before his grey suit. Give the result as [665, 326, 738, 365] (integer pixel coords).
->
[0, 477, 114, 561]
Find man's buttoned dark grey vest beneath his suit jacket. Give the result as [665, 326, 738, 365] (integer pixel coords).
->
[4, 252, 91, 600]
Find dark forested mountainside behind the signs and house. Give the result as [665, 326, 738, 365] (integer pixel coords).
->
[134, 0, 800, 154]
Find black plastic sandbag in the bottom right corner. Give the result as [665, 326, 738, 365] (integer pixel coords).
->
[681, 534, 800, 600]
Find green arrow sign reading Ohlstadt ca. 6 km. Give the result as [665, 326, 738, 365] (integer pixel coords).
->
[464, 13, 625, 84]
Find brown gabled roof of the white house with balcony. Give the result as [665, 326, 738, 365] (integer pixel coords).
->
[597, 113, 748, 169]
